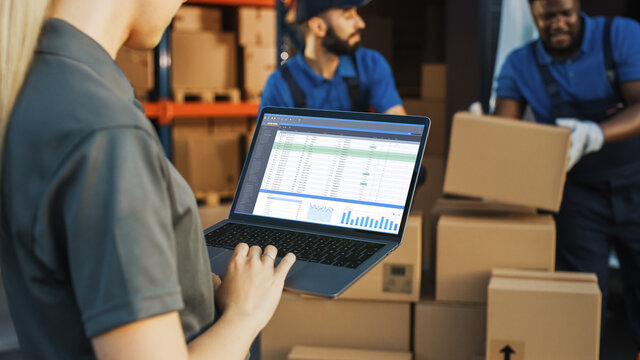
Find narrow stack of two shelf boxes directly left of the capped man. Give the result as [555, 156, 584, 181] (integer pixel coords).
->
[238, 6, 277, 101]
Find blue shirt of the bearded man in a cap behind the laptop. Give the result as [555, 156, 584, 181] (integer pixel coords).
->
[260, 48, 402, 112]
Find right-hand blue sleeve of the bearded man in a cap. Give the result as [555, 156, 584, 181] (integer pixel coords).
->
[362, 50, 402, 113]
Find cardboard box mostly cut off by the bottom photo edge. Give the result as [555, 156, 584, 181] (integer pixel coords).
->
[287, 346, 412, 360]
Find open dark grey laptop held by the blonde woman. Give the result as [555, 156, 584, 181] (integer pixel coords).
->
[204, 107, 431, 298]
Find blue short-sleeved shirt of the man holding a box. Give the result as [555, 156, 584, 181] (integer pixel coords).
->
[497, 13, 640, 123]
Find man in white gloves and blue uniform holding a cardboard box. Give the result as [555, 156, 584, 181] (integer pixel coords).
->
[495, 0, 640, 359]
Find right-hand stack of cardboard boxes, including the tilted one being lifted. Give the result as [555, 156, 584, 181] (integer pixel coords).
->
[414, 113, 600, 360]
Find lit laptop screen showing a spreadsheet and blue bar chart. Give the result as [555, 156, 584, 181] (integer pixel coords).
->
[235, 109, 425, 234]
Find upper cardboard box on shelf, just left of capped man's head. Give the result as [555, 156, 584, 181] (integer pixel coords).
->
[238, 6, 276, 48]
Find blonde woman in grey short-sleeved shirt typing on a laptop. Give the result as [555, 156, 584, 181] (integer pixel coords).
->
[0, 0, 295, 359]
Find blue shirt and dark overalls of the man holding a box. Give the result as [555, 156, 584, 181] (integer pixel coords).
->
[497, 14, 640, 349]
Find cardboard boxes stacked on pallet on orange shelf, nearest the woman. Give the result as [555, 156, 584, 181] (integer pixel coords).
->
[171, 5, 239, 102]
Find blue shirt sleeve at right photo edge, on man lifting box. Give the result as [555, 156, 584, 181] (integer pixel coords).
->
[611, 18, 640, 82]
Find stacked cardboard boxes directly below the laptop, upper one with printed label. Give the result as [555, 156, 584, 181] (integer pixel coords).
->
[261, 215, 422, 360]
